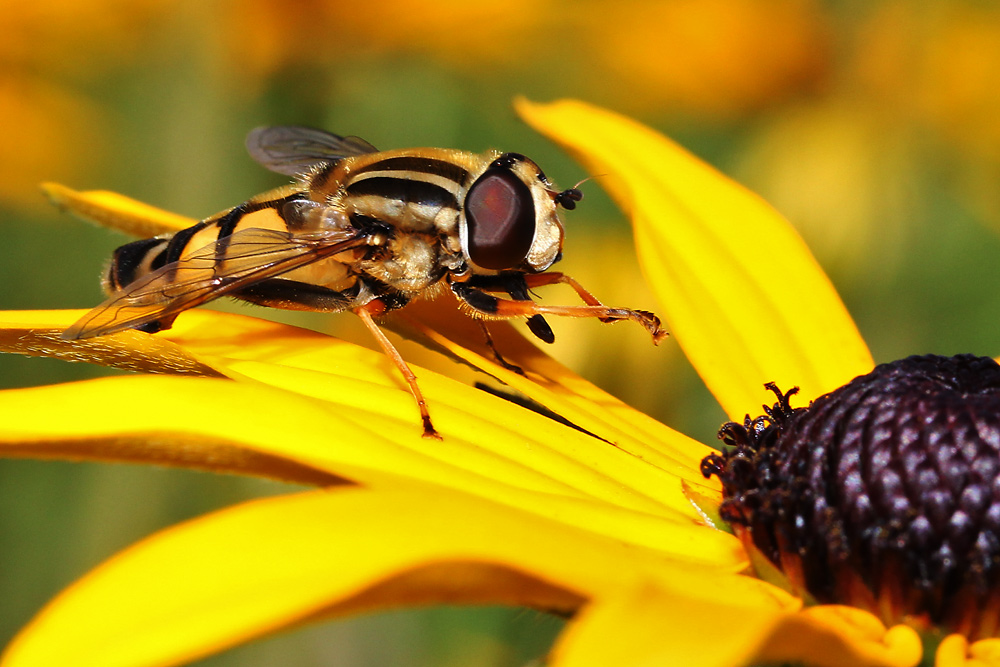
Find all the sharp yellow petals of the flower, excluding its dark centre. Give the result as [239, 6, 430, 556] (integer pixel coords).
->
[0, 102, 1000, 667]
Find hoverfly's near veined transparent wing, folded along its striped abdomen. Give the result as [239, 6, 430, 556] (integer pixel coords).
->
[62, 229, 367, 340]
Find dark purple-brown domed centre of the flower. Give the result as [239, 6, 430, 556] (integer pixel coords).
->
[702, 355, 1000, 639]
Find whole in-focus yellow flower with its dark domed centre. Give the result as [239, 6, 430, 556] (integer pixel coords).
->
[0, 102, 1000, 667]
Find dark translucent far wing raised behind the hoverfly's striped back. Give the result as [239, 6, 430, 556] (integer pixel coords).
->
[247, 125, 378, 176]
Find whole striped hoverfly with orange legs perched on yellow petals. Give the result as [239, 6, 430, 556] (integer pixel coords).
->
[63, 126, 666, 438]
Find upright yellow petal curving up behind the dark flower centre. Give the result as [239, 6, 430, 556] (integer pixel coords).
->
[517, 100, 873, 419]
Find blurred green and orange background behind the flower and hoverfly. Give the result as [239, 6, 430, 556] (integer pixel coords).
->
[0, 0, 1000, 667]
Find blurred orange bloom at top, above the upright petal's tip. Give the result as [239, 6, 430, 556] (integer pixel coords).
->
[573, 0, 831, 118]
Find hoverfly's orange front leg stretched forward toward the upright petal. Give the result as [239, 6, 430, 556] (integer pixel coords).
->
[451, 279, 667, 343]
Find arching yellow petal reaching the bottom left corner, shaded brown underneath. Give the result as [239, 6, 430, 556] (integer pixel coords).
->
[0, 477, 704, 667]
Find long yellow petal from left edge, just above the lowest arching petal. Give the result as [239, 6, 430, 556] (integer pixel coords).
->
[0, 374, 746, 571]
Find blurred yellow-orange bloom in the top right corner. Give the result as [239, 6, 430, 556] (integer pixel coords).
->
[841, 0, 1000, 228]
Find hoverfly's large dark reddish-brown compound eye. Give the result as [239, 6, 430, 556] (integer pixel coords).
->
[465, 167, 535, 270]
